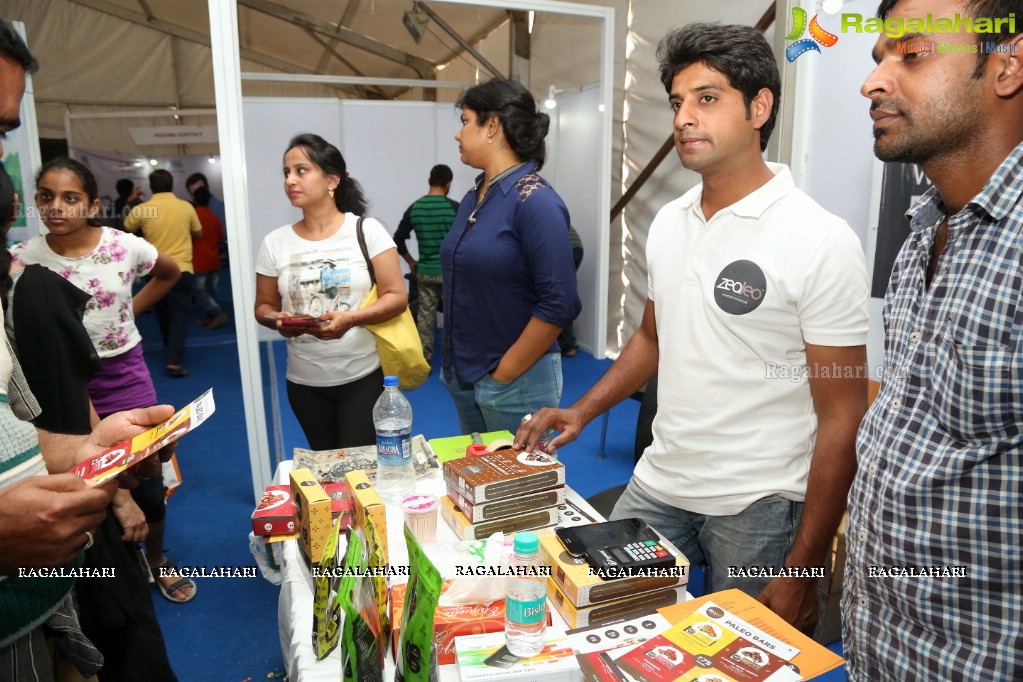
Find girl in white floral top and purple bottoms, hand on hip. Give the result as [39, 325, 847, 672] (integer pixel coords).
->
[11, 157, 195, 602]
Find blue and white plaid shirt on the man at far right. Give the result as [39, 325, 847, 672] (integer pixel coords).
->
[842, 143, 1023, 682]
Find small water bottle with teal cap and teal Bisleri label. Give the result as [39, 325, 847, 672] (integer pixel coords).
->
[504, 532, 547, 658]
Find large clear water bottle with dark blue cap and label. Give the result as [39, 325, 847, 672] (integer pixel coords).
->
[373, 376, 415, 502]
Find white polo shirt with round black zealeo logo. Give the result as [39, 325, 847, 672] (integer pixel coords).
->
[635, 164, 870, 515]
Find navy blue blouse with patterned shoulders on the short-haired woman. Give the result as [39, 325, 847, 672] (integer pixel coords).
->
[441, 162, 582, 383]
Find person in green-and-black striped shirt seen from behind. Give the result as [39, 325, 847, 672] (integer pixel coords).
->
[394, 164, 458, 362]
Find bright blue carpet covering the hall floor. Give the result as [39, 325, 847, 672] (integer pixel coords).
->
[131, 271, 846, 682]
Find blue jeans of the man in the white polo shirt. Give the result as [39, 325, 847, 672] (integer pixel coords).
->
[611, 476, 803, 597]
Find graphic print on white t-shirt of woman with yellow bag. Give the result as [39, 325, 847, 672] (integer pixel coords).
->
[284, 253, 352, 317]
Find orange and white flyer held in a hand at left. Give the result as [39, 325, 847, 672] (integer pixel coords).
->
[71, 389, 217, 486]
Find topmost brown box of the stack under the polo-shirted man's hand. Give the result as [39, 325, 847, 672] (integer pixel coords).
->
[444, 450, 565, 504]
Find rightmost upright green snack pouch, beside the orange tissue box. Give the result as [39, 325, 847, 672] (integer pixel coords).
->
[394, 526, 444, 682]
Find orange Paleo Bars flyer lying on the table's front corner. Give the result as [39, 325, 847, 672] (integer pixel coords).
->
[617, 590, 844, 682]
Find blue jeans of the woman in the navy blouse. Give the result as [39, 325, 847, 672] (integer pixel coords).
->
[441, 353, 562, 434]
